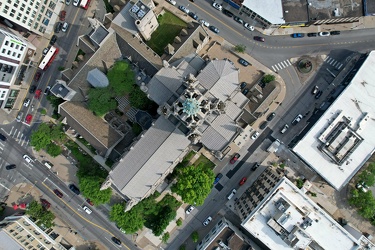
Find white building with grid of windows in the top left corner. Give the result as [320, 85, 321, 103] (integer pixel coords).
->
[0, 0, 63, 35]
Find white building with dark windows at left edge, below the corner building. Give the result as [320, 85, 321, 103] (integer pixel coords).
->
[0, 28, 35, 109]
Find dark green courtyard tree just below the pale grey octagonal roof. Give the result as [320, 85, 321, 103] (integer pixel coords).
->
[88, 87, 117, 116]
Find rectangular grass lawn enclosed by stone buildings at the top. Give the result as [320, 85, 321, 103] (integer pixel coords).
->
[146, 11, 187, 56]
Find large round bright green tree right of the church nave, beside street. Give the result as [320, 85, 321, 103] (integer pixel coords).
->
[172, 165, 214, 206]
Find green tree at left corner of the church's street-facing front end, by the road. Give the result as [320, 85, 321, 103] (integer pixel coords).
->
[79, 175, 112, 205]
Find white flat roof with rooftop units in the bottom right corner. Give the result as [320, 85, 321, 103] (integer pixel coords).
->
[241, 177, 375, 250]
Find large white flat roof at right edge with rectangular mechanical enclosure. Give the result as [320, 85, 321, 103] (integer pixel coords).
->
[293, 51, 375, 190]
